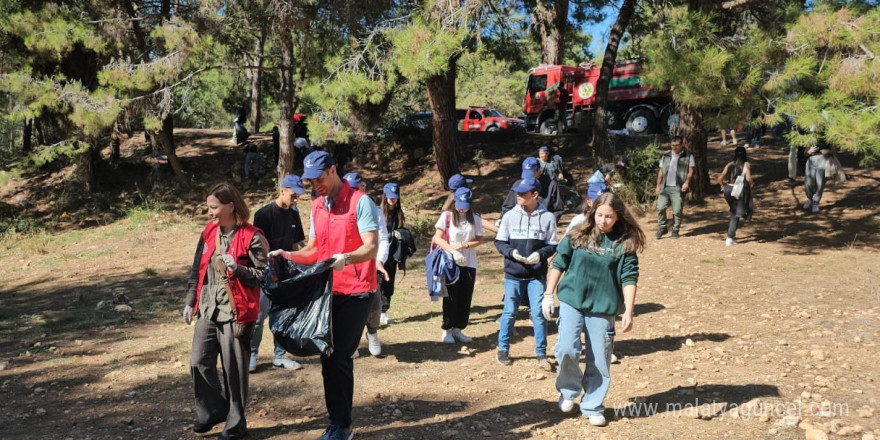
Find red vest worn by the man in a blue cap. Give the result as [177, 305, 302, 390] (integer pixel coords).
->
[312, 182, 376, 295]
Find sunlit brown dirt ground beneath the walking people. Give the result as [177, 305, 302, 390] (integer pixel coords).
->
[0, 131, 880, 440]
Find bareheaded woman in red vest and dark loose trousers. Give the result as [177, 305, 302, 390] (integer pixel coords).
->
[183, 183, 269, 440]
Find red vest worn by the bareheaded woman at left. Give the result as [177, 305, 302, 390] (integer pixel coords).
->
[195, 223, 261, 324]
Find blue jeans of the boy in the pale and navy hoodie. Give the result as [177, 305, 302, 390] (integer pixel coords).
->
[498, 278, 547, 357]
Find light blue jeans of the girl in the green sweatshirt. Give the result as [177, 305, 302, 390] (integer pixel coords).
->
[556, 303, 614, 417]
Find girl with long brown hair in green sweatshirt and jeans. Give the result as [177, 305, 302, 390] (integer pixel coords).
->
[541, 192, 645, 426]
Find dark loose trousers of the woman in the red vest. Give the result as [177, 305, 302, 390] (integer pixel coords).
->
[189, 317, 251, 435]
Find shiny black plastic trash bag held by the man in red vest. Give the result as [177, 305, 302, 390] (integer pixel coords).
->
[263, 257, 333, 356]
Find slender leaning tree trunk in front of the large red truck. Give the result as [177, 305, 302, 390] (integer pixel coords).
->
[593, 0, 636, 163]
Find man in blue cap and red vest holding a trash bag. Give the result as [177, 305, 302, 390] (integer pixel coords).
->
[269, 151, 379, 440]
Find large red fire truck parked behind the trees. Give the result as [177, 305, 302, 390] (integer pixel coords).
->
[523, 61, 674, 134]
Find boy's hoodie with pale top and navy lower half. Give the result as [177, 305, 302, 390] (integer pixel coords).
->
[495, 205, 558, 280]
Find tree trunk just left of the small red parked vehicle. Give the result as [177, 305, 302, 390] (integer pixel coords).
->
[425, 57, 459, 190]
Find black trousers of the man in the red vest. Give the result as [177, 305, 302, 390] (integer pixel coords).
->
[321, 295, 370, 428]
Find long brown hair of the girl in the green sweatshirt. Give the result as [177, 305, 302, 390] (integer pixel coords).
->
[571, 192, 645, 254]
